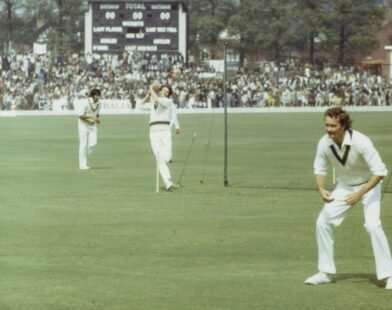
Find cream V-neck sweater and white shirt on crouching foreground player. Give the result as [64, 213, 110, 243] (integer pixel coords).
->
[314, 130, 388, 186]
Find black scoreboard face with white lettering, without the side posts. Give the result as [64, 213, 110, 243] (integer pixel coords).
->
[92, 2, 179, 54]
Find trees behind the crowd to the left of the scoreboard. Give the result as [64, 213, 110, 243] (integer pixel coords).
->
[0, 0, 86, 54]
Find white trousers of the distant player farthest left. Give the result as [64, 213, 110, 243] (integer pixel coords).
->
[78, 120, 98, 169]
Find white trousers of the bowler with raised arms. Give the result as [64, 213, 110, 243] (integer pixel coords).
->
[150, 125, 173, 189]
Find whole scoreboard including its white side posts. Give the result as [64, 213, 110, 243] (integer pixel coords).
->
[85, 0, 187, 60]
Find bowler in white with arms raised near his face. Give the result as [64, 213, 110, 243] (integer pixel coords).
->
[142, 83, 179, 191]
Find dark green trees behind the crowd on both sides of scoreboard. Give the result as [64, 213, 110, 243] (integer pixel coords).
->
[0, 0, 388, 63]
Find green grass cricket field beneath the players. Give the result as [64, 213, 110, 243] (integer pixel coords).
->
[0, 113, 392, 310]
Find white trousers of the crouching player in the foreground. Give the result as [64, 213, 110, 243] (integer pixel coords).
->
[316, 183, 392, 280]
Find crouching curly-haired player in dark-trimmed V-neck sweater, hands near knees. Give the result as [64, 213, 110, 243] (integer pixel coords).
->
[305, 107, 392, 290]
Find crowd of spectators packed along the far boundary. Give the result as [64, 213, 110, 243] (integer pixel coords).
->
[0, 53, 392, 110]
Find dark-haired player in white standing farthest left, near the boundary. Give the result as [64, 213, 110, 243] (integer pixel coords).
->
[78, 88, 101, 170]
